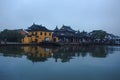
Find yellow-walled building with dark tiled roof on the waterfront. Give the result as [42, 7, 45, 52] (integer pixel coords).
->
[22, 24, 52, 43]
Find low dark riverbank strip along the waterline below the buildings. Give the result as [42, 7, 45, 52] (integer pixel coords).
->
[0, 42, 120, 46]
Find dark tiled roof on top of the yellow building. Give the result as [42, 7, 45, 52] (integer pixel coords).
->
[26, 24, 51, 32]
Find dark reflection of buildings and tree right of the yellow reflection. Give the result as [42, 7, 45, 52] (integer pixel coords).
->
[53, 46, 108, 62]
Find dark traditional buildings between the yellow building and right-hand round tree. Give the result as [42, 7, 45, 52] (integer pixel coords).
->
[53, 25, 91, 44]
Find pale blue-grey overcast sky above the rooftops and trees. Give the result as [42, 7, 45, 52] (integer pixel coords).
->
[0, 0, 120, 36]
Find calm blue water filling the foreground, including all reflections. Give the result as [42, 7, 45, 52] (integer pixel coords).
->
[0, 46, 120, 80]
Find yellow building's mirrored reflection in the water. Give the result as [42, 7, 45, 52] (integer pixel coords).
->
[23, 46, 52, 62]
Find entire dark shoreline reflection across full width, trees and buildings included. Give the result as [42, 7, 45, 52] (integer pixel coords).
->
[0, 46, 120, 62]
